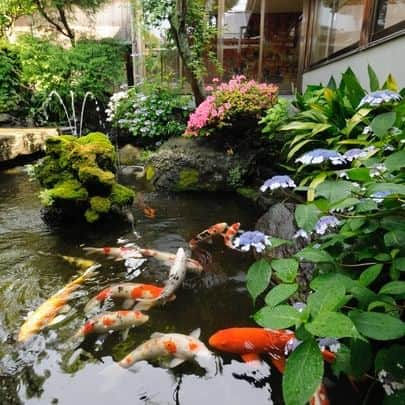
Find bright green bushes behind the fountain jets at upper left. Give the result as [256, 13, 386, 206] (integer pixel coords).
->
[17, 35, 125, 121]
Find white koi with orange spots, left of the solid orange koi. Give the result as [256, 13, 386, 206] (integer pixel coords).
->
[118, 329, 212, 368]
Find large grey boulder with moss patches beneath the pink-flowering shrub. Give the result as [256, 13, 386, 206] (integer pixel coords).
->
[146, 138, 255, 192]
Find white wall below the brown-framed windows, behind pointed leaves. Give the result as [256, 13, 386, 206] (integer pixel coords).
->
[303, 36, 405, 90]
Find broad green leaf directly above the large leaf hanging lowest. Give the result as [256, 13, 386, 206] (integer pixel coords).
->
[305, 312, 359, 338]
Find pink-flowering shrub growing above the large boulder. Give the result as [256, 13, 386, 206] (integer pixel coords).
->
[184, 76, 278, 136]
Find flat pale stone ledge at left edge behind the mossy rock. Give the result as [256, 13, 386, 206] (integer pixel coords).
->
[0, 128, 58, 162]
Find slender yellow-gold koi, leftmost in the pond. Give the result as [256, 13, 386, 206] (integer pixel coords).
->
[17, 264, 100, 342]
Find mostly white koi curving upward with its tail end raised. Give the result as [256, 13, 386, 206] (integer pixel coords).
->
[138, 248, 187, 305]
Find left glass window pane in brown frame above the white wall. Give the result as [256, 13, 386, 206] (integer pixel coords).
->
[311, 0, 365, 63]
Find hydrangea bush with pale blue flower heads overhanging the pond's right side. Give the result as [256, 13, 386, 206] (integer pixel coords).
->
[245, 68, 405, 405]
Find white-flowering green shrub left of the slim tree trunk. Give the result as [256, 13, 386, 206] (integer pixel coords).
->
[106, 81, 191, 144]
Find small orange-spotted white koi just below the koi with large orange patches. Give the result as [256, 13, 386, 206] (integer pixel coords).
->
[76, 310, 149, 339]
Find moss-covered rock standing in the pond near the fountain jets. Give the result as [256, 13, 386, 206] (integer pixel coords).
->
[34, 132, 134, 223]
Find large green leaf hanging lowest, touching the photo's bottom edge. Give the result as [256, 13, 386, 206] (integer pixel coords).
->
[283, 339, 323, 405]
